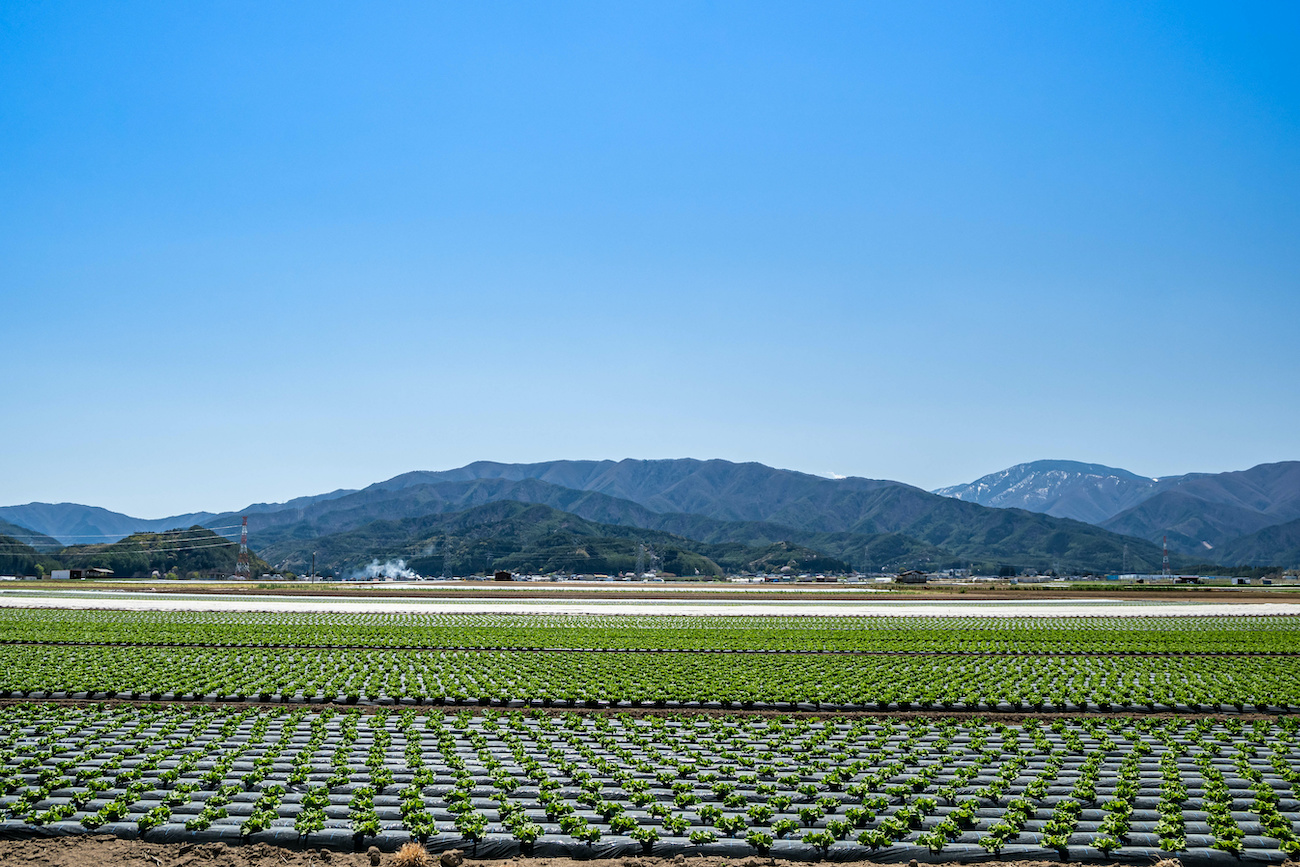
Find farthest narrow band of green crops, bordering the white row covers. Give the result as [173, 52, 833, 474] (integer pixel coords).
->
[0, 608, 1300, 654]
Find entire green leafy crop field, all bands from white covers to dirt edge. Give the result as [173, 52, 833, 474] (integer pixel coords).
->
[0, 606, 1300, 863]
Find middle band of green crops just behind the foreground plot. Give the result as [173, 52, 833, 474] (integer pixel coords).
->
[0, 645, 1300, 712]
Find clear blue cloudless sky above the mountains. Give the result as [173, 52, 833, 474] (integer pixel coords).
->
[0, 0, 1300, 517]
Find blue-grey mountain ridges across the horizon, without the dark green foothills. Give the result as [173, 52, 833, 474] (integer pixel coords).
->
[10, 459, 1300, 572]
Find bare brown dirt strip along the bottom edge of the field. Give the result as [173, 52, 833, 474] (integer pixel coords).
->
[0, 836, 1196, 867]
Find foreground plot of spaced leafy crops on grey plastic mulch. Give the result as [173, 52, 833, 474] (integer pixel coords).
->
[0, 703, 1300, 862]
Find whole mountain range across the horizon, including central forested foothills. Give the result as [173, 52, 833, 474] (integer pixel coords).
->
[0, 459, 1300, 573]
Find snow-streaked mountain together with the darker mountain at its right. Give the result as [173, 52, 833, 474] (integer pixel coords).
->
[935, 460, 1300, 565]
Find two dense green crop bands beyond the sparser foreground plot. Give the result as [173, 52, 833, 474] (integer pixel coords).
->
[0, 610, 1300, 712]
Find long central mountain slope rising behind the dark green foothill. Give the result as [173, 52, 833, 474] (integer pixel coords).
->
[231, 460, 1160, 571]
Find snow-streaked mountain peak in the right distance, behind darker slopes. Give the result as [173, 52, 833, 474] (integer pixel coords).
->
[935, 460, 1184, 524]
